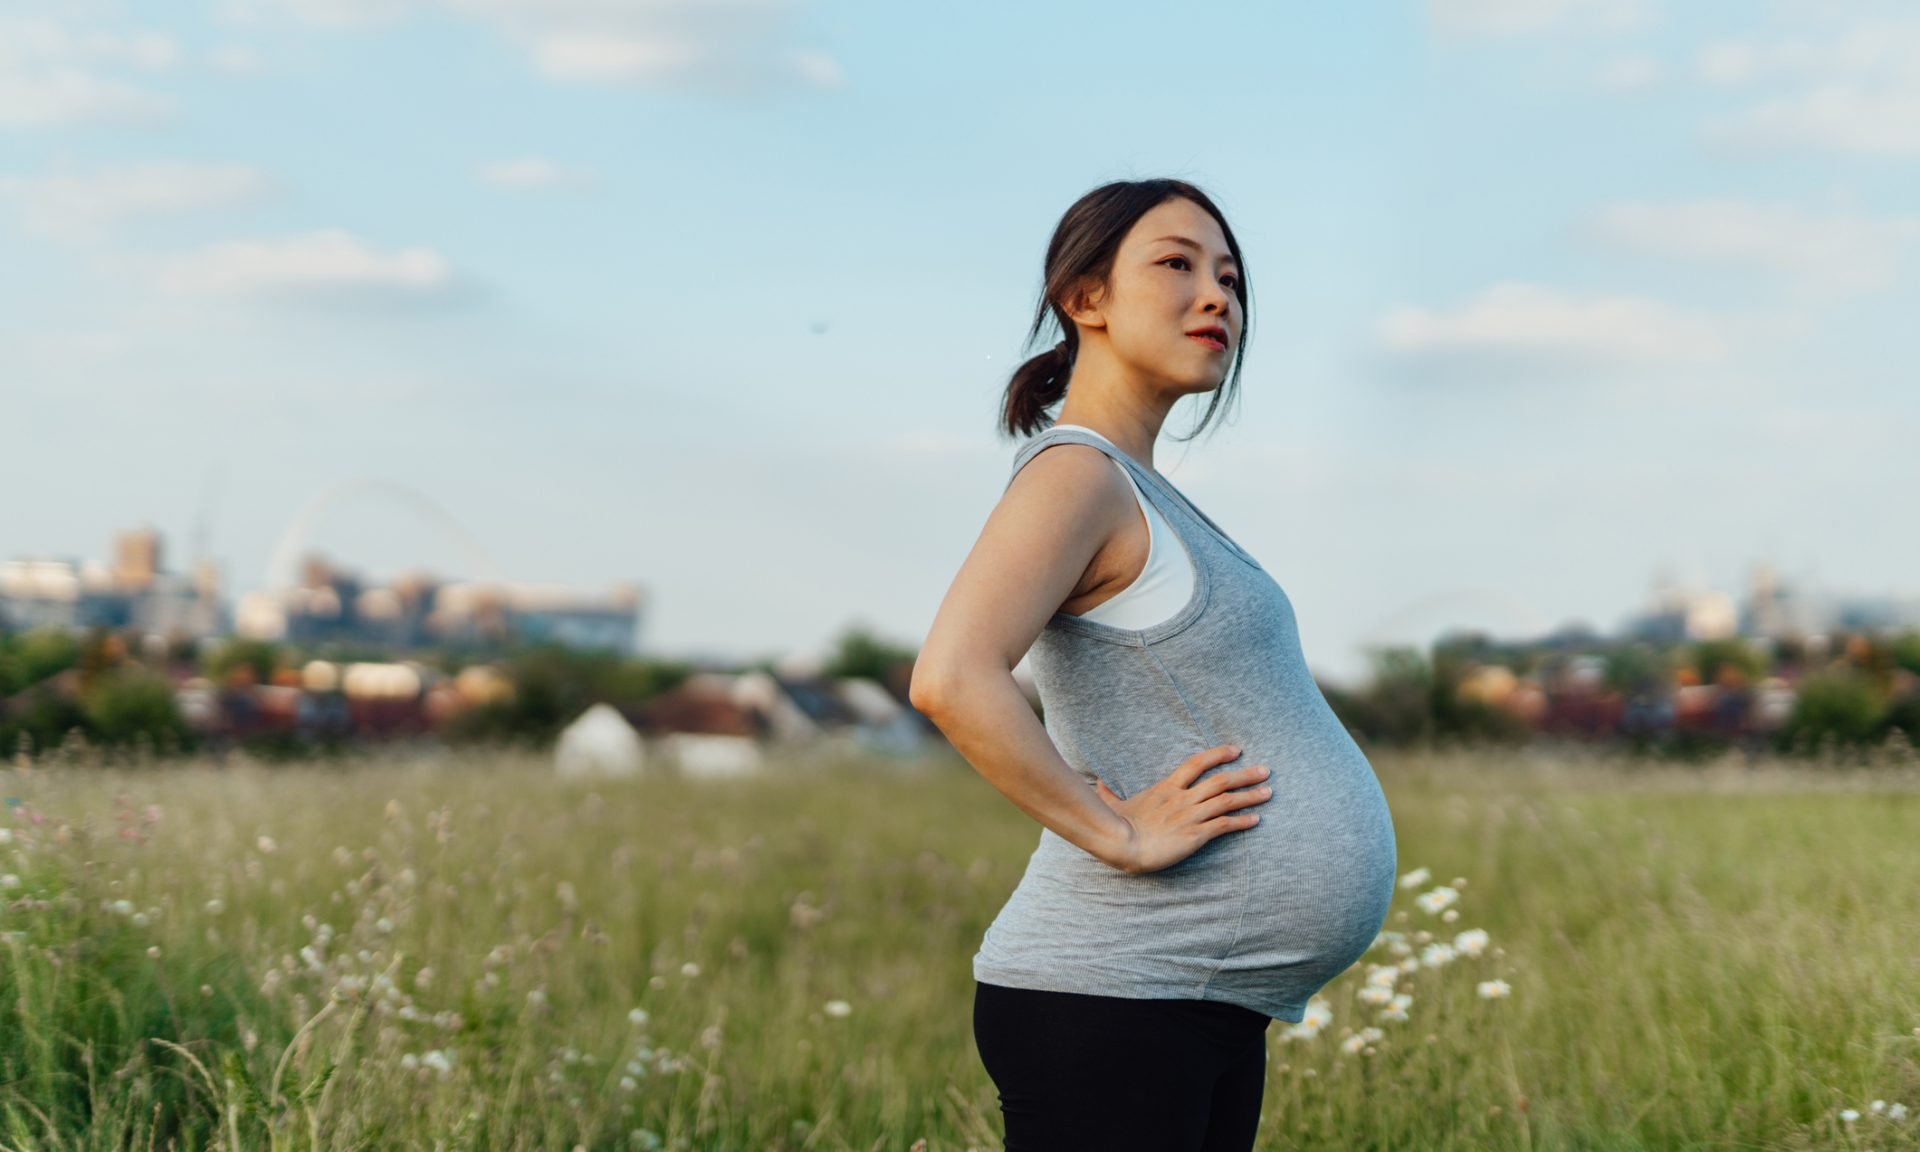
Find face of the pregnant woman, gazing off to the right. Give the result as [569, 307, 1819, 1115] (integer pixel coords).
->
[1075, 198, 1244, 394]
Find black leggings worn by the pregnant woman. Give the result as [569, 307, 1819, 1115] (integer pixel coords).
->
[973, 981, 1269, 1152]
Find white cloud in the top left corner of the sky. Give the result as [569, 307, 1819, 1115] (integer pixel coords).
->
[0, 19, 180, 131]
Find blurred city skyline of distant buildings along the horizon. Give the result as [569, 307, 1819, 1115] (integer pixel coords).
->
[0, 526, 1920, 689]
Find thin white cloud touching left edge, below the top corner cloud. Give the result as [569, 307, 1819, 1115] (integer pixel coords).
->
[0, 161, 273, 236]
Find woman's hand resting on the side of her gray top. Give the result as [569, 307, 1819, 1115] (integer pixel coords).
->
[1094, 745, 1273, 872]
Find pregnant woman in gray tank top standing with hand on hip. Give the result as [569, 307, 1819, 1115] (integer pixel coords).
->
[912, 180, 1396, 1152]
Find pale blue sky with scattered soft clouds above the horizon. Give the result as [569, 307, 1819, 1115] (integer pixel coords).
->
[0, 0, 1920, 680]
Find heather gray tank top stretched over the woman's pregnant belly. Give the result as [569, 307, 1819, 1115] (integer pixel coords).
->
[973, 428, 1398, 1023]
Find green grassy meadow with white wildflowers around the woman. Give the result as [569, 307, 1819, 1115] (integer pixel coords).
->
[0, 737, 1920, 1152]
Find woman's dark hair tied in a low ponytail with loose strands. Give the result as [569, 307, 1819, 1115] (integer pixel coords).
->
[1000, 180, 1254, 440]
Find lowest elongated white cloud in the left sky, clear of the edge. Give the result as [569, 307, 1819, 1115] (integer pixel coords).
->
[165, 228, 453, 298]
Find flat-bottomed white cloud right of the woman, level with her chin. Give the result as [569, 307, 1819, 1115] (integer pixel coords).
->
[1379, 280, 1726, 365]
